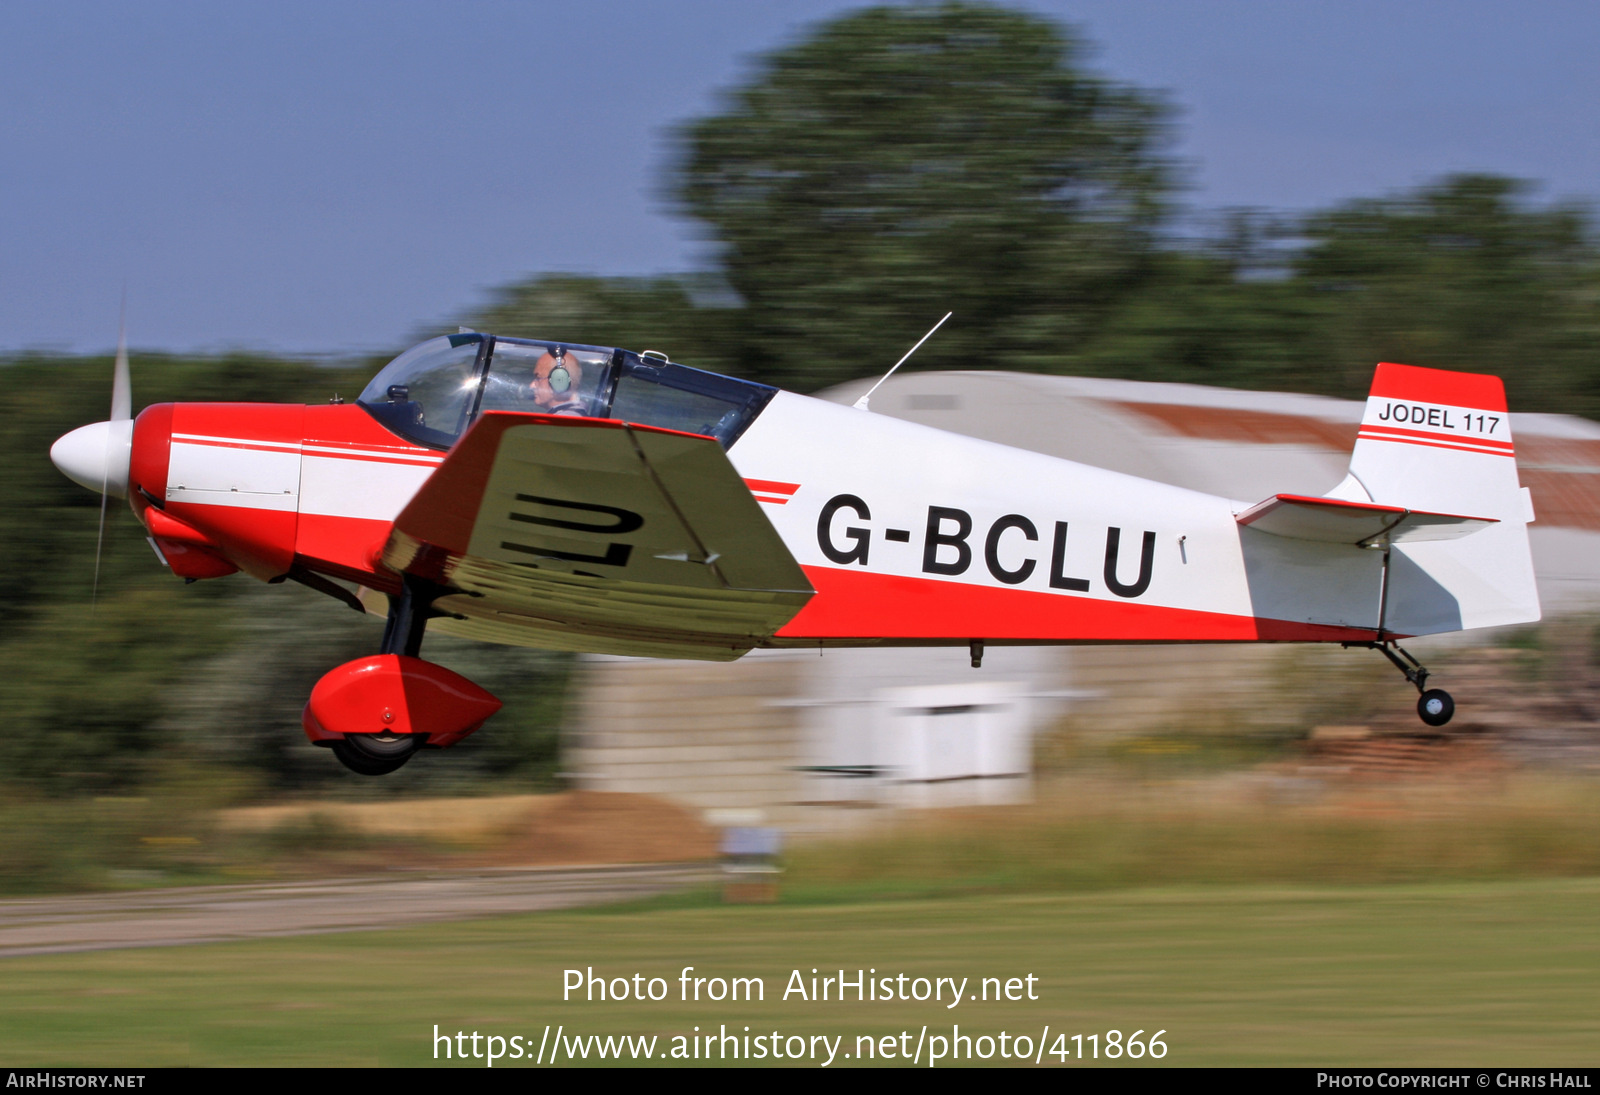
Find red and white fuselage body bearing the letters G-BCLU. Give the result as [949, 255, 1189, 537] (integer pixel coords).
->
[103, 374, 1378, 650]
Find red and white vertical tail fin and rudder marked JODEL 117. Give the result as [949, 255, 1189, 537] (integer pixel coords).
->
[1330, 362, 1539, 636]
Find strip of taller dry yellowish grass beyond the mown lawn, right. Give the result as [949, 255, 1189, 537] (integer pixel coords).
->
[786, 776, 1600, 901]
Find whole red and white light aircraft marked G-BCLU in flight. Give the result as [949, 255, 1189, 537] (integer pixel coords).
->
[51, 333, 1539, 775]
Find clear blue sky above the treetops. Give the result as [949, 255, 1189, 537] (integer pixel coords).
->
[0, 0, 1600, 354]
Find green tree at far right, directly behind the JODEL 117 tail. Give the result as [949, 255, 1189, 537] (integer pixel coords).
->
[1294, 174, 1600, 415]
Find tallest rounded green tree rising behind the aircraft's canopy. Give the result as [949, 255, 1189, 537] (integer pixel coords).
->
[670, 3, 1170, 389]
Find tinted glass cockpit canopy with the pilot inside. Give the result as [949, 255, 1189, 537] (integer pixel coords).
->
[358, 331, 778, 448]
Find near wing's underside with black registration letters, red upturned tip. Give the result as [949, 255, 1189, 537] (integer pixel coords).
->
[382, 411, 813, 660]
